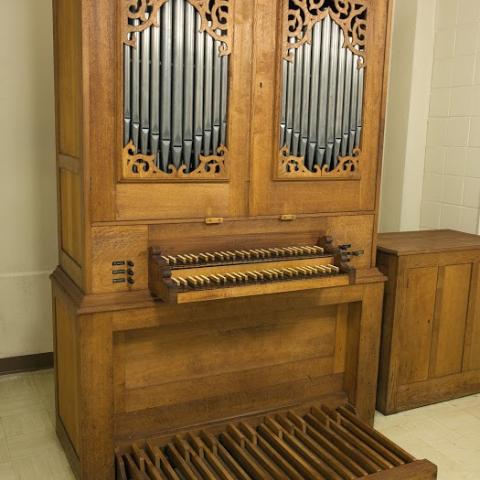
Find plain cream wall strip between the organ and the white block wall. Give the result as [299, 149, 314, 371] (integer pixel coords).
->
[379, 0, 436, 232]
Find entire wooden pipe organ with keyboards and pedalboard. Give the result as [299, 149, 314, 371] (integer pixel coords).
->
[52, 0, 436, 480]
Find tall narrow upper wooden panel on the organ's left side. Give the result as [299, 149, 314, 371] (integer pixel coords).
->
[53, 0, 82, 158]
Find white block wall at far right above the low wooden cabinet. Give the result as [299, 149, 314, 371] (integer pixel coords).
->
[421, 0, 480, 233]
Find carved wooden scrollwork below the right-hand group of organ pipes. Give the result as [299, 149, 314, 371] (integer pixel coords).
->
[278, 147, 361, 180]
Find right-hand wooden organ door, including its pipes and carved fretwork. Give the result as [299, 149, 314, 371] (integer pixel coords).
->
[250, 0, 389, 214]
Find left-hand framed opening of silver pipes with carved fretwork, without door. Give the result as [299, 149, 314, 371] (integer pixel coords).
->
[121, 0, 232, 181]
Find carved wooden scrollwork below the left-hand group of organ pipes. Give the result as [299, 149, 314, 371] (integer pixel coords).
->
[123, 142, 228, 180]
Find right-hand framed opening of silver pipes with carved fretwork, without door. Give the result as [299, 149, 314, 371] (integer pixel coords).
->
[275, 0, 368, 180]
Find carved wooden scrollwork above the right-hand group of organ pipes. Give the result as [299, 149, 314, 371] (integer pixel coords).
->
[283, 0, 367, 68]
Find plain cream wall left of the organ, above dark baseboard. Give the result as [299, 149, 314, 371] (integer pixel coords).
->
[0, 0, 57, 358]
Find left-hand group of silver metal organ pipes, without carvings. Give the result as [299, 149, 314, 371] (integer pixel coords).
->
[124, 0, 228, 172]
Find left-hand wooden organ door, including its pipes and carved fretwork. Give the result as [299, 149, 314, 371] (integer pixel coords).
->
[90, 0, 253, 221]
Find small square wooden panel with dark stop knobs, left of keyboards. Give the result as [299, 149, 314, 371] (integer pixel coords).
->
[91, 225, 148, 293]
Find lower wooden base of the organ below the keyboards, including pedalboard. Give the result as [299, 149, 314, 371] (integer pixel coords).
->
[53, 270, 436, 480]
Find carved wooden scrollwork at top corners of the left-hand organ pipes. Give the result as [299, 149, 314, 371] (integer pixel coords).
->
[124, 0, 232, 56]
